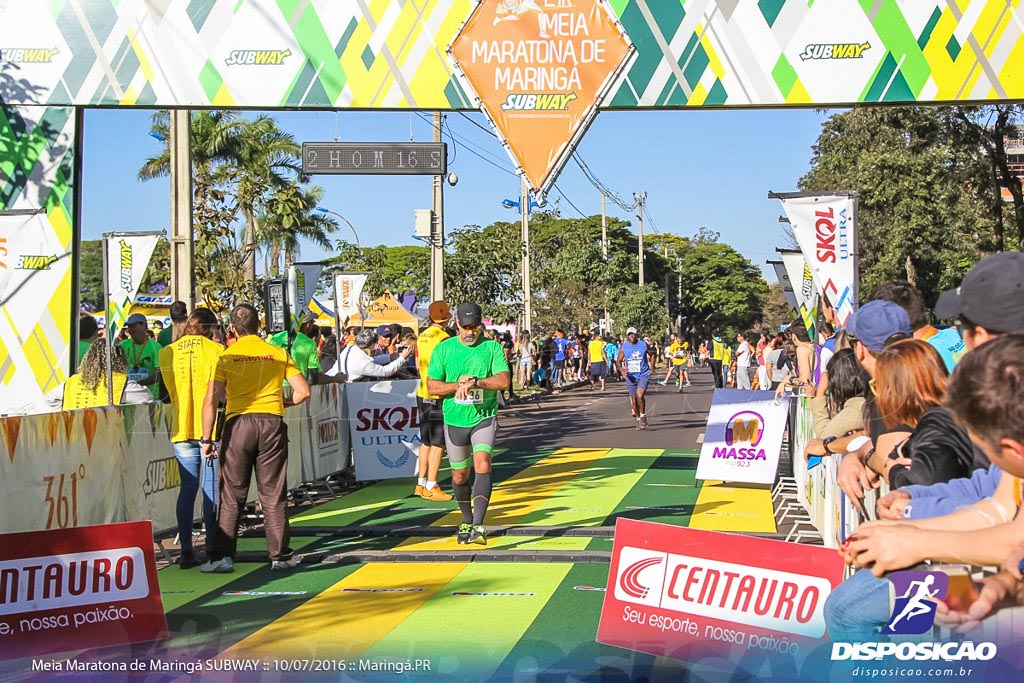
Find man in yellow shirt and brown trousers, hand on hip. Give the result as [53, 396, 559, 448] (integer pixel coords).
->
[200, 303, 309, 573]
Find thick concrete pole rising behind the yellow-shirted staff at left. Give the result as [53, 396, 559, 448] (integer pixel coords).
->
[168, 110, 196, 310]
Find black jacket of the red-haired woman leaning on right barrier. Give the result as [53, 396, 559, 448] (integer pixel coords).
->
[889, 407, 990, 488]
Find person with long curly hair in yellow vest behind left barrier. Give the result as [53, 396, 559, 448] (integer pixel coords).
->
[43, 339, 153, 411]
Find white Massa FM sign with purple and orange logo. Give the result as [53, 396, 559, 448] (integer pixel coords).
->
[696, 389, 790, 483]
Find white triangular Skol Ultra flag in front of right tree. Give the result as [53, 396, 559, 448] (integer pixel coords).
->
[778, 195, 857, 325]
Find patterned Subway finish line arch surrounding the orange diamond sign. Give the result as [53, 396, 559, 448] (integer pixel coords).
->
[0, 0, 1024, 410]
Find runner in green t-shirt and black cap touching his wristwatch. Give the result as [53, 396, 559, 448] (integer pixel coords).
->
[427, 302, 510, 546]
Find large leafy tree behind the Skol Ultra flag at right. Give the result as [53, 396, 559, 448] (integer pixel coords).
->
[799, 106, 993, 304]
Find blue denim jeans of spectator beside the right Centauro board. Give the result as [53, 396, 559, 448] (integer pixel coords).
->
[824, 569, 891, 643]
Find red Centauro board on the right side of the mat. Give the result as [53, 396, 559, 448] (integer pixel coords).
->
[597, 517, 844, 680]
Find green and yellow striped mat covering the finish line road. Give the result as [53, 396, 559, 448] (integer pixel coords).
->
[153, 449, 775, 680]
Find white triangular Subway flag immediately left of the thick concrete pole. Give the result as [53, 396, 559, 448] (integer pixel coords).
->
[103, 232, 162, 339]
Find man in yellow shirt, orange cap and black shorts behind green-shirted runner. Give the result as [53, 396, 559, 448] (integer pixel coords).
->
[416, 301, 452, 501]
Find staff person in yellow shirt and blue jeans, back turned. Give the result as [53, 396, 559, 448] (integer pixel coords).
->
[160, 308, 224, 569]
